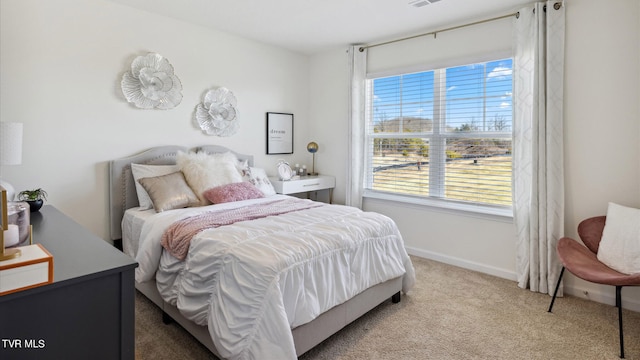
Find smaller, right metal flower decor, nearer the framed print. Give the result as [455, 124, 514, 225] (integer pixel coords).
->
[195, 87, 239, 136]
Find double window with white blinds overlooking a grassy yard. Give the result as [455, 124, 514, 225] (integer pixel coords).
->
[365, 59, 513, 208]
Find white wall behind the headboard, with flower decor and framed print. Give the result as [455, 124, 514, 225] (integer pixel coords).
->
[0, 0, 309, 239]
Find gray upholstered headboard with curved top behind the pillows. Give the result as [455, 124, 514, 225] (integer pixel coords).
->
[109, 145, 253, 240]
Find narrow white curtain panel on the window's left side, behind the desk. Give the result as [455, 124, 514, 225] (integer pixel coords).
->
[345, 45, 367, 208]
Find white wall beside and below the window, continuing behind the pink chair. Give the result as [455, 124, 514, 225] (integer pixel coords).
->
[310, 0, 640, 311]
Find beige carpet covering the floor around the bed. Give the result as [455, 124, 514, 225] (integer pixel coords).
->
[136, 257, 640, 360]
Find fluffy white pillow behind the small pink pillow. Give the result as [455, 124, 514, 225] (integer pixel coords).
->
[176, 151, 242, 205]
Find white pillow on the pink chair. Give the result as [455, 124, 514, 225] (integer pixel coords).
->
[598, 203, 640, 274]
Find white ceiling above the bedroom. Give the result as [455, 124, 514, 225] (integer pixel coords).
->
[111, 0, 532, 55]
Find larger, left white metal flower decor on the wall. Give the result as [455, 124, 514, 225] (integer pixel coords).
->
[121, 53, 182, 110]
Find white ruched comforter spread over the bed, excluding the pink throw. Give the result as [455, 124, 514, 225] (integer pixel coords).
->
[136, 195, 415, 359]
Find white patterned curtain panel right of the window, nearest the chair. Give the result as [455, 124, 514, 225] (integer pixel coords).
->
[513, 1, 565, 294]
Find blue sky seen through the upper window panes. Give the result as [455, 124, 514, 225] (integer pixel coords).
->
[373, 59, 512, 131]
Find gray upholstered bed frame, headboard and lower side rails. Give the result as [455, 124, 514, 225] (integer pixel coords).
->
[109, 145, 402, 358]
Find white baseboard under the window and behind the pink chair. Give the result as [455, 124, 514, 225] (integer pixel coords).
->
[407, 247, 640, 312]
